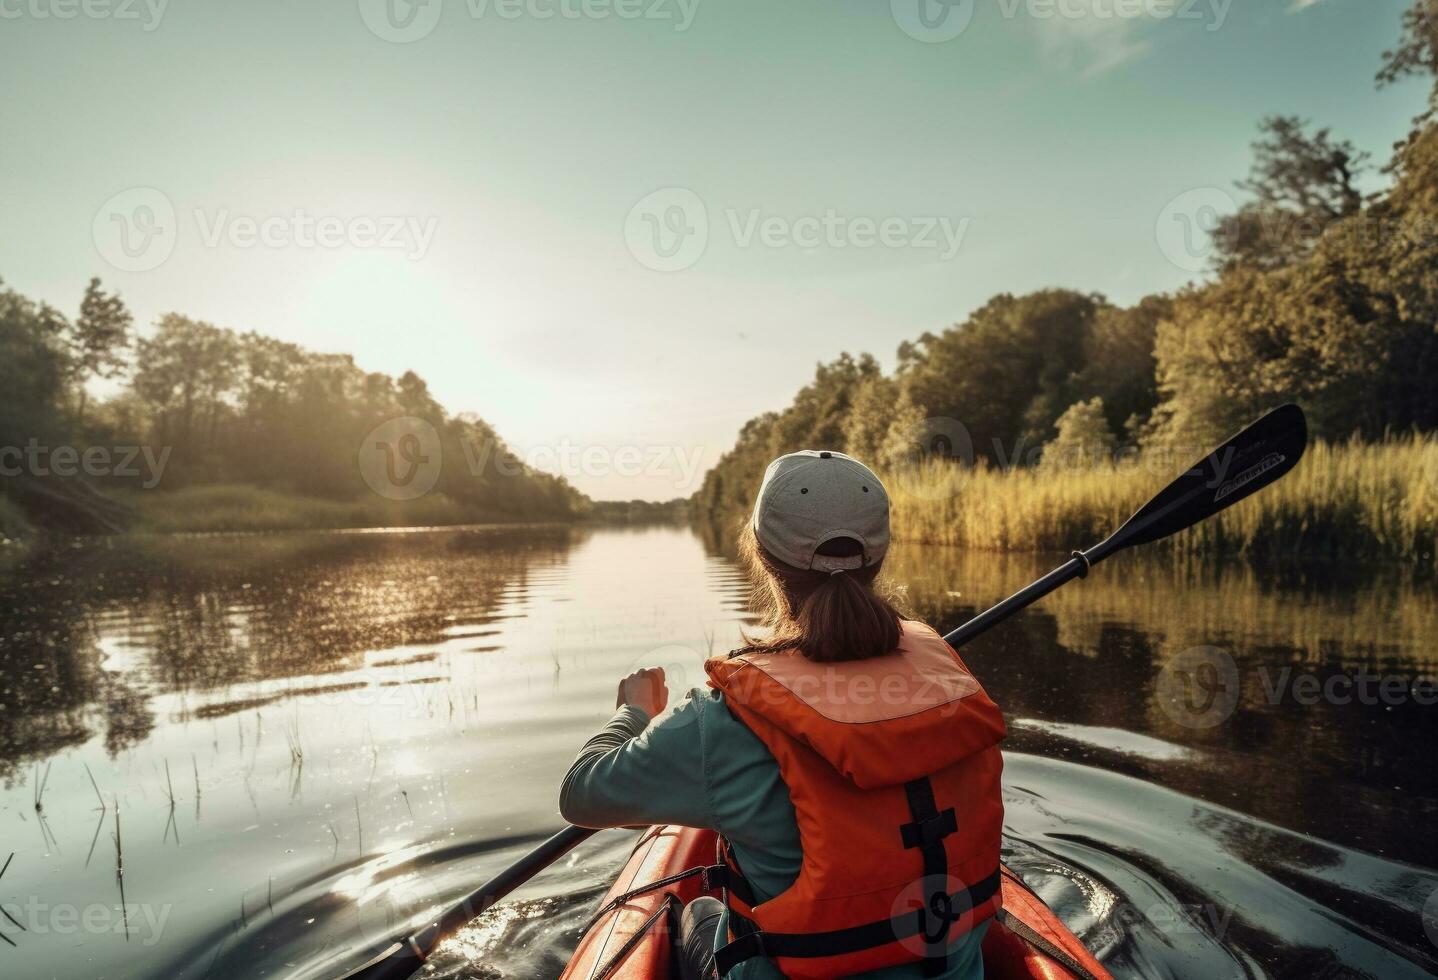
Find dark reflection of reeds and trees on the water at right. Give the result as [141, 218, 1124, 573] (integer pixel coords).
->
[893, 549, 1438, 868]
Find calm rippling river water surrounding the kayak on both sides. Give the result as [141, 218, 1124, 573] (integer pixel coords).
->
[0, 527, 1438, 980]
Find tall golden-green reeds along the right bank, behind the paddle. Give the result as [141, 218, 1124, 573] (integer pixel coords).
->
[886, 437, 1438, 568]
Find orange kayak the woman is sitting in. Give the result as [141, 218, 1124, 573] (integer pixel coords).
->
[564, 826, 1113, 980]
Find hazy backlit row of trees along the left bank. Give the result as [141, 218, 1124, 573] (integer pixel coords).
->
[0, 279, 588, 530]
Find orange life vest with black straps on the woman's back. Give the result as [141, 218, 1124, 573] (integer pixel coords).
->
[705, 622, 1004, 980]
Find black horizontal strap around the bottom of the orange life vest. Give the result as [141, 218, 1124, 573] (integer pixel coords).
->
[715, 868, 999, 976]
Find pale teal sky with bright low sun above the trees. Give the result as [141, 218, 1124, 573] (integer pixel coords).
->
[0, 0, 1425, 500]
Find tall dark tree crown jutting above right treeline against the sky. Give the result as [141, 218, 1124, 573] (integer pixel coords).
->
[1214, 116, 1368, 270]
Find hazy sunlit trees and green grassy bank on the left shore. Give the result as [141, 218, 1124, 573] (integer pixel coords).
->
[0, 280, 588, 529]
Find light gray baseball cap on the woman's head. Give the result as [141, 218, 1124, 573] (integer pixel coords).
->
[754, 450, 889, 572]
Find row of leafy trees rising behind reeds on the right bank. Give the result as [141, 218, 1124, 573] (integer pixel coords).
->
[695, 0, 1438, 520]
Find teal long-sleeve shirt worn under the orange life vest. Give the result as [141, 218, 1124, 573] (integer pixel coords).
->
[559, 688, 986, 980]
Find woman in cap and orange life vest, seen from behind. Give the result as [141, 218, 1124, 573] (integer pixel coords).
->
[559, 451, 1004, 980]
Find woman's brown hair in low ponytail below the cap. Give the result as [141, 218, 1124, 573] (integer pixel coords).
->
[736, 522, 902, 662]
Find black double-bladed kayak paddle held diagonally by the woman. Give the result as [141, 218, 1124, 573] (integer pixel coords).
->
[339, 405, 1309, 980]
